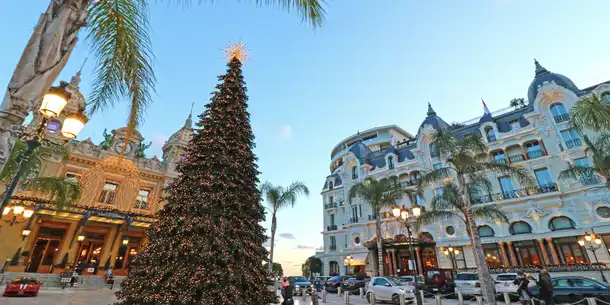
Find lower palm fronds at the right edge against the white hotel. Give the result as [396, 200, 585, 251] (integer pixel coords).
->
[559, 133, 610, 187]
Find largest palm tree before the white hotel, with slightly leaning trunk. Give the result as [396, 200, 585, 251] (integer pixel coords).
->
[418, 131, 534, 304]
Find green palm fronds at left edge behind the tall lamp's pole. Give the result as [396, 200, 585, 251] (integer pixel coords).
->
[0, 141, 80, 209]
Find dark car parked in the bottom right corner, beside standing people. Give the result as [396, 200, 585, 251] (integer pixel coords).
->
[530, 276, 610, 304]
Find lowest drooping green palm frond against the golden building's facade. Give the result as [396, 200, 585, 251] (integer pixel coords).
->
[24, 177, 80, 210]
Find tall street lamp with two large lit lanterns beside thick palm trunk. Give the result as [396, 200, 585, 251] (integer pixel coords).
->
[0, 86, 87, 211]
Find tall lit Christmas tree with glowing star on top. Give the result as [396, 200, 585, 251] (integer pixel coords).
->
[117, 44, 275, 305]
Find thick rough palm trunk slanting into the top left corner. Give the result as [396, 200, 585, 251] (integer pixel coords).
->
[0, 0, 89, 171]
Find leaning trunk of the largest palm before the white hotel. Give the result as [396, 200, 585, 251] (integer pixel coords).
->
[457, 175, 496, 305]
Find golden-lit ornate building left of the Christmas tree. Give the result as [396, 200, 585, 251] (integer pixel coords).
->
[0, 74, 193, 275]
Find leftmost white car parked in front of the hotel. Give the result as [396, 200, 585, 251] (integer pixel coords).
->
[366, 276, 415, 304]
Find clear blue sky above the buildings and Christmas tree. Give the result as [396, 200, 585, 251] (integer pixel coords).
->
[0, 0, 610, 274]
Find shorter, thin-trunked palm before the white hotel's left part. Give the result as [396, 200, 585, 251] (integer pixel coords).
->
[349, 177, 421, 276]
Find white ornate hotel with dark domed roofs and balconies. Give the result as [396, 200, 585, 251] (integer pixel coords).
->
[317, 62, 610, 275]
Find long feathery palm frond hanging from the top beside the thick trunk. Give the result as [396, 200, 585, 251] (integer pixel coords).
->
[87, 0, 156, 139]
